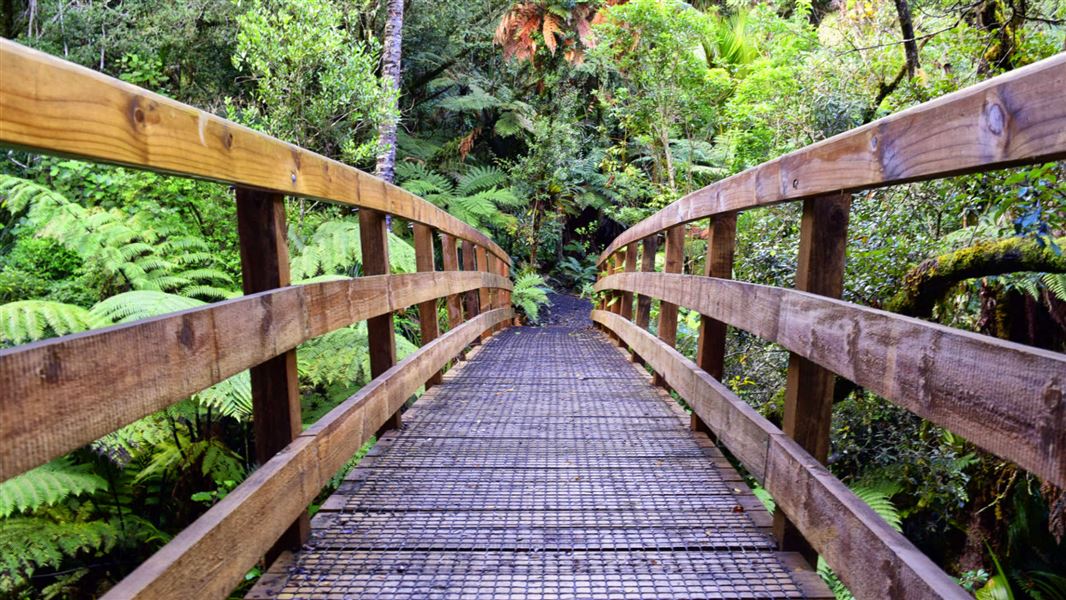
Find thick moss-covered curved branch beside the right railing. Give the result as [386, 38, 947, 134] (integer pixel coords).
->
[886, 238, 1066, 317]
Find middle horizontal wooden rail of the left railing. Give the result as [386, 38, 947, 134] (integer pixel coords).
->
[0, 272, 511, 481]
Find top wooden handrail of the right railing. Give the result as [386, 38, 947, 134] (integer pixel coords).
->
[598, 53, 1066, 264]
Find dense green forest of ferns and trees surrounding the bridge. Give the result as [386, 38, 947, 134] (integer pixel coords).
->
[0, 0, 1066, 600]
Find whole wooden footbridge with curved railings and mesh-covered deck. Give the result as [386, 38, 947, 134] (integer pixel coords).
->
[0, 40, 1066, 599]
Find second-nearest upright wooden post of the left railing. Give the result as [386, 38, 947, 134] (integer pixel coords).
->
[359, 209, 401, 432]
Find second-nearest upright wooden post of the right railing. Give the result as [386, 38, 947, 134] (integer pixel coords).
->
[691, 212, 737, 434]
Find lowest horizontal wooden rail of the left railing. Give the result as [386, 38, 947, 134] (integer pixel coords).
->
[104, 308, 513, 600]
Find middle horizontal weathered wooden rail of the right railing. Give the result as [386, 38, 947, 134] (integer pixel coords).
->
[596, 273, 1066, 486]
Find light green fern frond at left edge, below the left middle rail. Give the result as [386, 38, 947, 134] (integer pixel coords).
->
[0, 458, 108, 518]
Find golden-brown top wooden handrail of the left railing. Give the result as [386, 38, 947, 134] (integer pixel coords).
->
[0, 39, 511, 264]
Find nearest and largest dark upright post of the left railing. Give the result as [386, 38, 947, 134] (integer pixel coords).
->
[237, 188, 310, 565]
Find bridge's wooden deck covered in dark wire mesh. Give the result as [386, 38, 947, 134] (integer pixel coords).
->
[249, 327, 831, 600]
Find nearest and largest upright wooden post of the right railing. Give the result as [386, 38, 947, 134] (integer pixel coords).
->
[774, 193, 852, 564]
